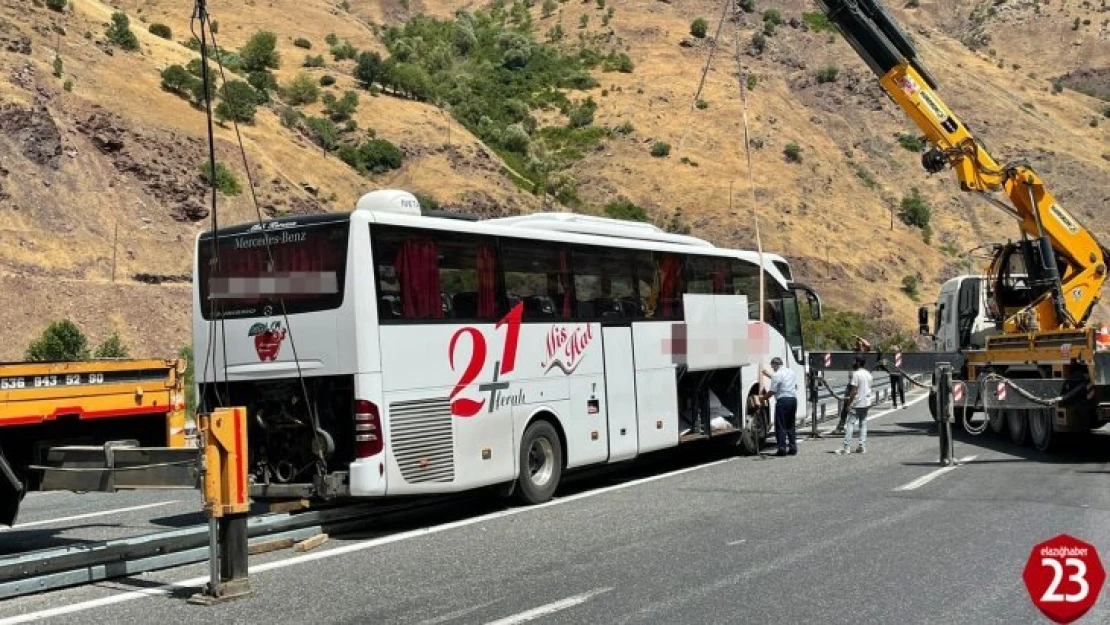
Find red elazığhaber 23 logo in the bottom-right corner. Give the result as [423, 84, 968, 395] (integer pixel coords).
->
[1021, 534, 1107, 623]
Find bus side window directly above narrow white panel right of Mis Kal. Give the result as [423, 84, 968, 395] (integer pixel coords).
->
[571, 248, 643, 320]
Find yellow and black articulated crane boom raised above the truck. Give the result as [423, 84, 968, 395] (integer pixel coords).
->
[817, 0, 1110, 333]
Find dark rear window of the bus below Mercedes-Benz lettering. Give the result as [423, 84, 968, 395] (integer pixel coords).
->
[196, 220, 350, 319]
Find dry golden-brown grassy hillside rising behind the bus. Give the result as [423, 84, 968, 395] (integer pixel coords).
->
[0, 0, 1110, 360]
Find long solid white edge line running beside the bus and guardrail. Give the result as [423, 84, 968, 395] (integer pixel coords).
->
[0, 457, 739, 625]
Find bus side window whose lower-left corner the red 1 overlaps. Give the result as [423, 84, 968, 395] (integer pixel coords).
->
[501, 239, 573, 321]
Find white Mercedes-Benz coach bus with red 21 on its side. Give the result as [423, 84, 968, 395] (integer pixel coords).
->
[193, 191, 819, 503]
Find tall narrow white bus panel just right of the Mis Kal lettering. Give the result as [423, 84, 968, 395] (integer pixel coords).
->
[602, 325, 639, 462]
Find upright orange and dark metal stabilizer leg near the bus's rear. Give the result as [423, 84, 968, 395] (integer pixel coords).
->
[189, 406, 251, 605]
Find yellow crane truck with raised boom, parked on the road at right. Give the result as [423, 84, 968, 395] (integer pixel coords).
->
[809, 0, 1110, 451]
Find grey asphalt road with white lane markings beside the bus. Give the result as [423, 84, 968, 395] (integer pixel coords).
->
[0, 393, 1110, 625]
